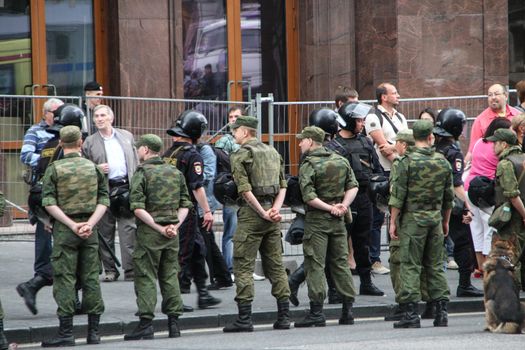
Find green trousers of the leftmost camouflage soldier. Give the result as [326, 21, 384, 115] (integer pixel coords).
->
[51, 217, 104, 316]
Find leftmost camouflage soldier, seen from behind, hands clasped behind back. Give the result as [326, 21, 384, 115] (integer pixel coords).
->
[42, 125, 109, 347]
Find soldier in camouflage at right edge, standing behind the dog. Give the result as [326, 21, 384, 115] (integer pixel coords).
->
[487, 129, 525, 285]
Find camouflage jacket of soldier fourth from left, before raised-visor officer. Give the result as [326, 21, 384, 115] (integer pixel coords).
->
[299, 147, 357, 203]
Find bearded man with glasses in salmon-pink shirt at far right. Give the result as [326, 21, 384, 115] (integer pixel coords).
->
[465, 84, 520, 162]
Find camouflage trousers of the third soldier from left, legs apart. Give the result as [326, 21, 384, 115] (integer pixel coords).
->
[233, 205, 290, 304]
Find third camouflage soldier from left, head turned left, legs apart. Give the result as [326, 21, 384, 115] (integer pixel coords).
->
[223, 116, 290, 332]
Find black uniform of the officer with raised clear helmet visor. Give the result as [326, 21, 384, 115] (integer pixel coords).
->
[326, 134, 383, 294]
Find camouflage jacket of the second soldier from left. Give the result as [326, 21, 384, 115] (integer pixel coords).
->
[129, 157, 193, 224]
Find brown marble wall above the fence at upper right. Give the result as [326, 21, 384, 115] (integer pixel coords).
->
[299, 0, 508, 99]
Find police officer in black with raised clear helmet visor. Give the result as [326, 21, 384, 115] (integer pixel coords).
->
[326, 102, 385, 296]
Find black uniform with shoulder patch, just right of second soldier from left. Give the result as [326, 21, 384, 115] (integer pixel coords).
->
[163, 142, 208, 291]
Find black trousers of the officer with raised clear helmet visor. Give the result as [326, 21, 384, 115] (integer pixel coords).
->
[346, 190, 373, 275]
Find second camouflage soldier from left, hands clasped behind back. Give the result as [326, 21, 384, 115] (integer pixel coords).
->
[124, 134, 193, 340]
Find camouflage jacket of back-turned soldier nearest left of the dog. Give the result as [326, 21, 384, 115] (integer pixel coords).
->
[388, 147, 454, 226]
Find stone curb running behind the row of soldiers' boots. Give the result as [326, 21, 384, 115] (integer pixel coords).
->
[5, 298, 485, 344]
